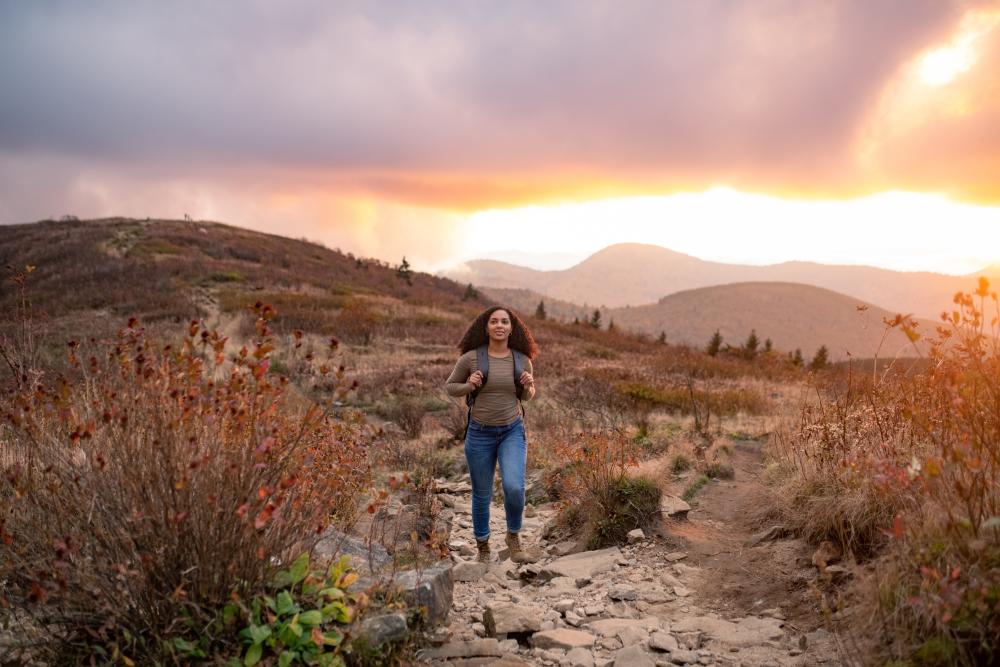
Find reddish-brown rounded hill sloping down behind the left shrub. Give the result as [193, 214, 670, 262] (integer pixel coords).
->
[0, 218, 484, 348]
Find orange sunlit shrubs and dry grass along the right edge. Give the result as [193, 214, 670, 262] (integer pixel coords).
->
[784, 279, 1000, 665]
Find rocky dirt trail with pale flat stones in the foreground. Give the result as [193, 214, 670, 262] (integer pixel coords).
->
[418, 441, 845, 667]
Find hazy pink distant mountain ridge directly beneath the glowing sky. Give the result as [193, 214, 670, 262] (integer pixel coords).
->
[445, 243, 996, 318]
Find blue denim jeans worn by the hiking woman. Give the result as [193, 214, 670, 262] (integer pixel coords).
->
[465, 417, 528, 541]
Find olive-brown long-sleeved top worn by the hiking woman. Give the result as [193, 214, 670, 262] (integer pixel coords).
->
[445, 350, 537, 426]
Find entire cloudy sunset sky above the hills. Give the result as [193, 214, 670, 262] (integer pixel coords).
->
[0, 0, 1000, 273]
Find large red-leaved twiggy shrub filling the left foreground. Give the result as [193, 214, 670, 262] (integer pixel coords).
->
[0, 304, 368, 663]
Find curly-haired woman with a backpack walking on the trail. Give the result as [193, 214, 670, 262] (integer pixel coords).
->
[446, 306, 538, 563]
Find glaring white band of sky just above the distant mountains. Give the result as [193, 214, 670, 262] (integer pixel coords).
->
[450, 187, 1000, 275]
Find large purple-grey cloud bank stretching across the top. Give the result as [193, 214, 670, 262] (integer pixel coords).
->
[0, 0, 965, 179]
